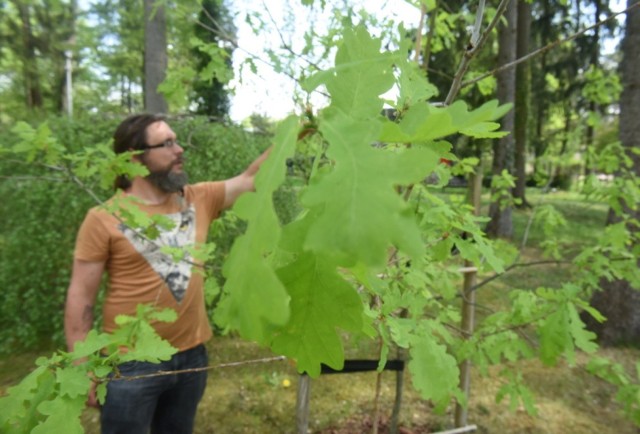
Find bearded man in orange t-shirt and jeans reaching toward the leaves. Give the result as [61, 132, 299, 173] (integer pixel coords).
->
[65, 114, 268, 434]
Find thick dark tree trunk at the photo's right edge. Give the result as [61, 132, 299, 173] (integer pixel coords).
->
[587, 0, 640, 345]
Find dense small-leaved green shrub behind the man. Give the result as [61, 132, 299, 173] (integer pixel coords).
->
[0, 117, 294, 352]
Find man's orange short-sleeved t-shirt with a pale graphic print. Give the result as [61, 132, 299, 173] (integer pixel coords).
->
[75, 182, 224, 351]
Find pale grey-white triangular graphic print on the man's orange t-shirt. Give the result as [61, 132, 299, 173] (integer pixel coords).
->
[118, 205, 196, 303]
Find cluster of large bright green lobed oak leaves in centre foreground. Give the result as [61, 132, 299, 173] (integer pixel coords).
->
[210, 27, 507, 403]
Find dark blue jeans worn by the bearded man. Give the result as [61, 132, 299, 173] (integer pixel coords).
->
[100, 345, 208, 434]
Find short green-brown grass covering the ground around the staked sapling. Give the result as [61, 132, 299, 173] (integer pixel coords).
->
[0, 193, 640, 434]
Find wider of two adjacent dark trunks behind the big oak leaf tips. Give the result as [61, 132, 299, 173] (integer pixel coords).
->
[487, 1, 518, 238]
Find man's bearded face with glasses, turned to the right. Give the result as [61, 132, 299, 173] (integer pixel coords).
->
[139, 121, 188, 193]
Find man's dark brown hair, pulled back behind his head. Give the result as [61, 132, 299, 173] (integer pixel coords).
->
[113, 113, 165, 190]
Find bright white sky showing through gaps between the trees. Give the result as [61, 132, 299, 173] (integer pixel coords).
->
[229, 0, 626, 122]
